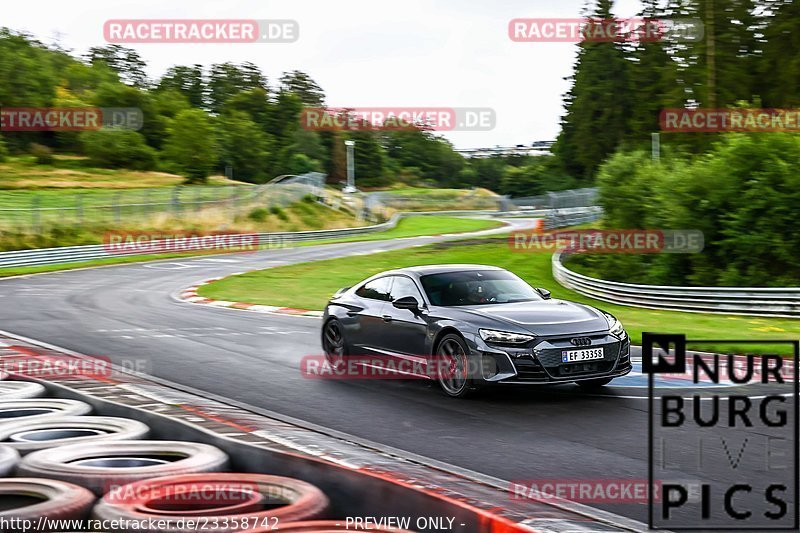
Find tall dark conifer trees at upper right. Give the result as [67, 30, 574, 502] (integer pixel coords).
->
[555, 0, 800, 183]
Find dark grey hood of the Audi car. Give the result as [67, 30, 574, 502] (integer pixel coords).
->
[460, 300, 608, 336]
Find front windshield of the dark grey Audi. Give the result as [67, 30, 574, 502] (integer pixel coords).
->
[421, 270, 542, 307]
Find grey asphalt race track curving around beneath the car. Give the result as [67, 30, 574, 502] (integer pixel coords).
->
[0, 220, 792, 520]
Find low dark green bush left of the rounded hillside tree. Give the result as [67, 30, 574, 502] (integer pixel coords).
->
[80, 129, 156, 170]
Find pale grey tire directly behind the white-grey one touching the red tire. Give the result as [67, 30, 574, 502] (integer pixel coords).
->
[0, 416, 150, 455]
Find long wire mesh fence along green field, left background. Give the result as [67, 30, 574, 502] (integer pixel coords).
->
[0, 172, 325, 233]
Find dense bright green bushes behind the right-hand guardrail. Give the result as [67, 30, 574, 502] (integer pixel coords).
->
[580, 133, 800, 286]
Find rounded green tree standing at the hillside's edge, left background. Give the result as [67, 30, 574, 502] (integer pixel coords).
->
[163, 109, 217, 183]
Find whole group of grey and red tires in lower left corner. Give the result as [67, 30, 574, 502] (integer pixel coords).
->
[0, 376, 329, 533]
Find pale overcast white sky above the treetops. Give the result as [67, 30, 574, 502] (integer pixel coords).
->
[0, 0, 639, 148]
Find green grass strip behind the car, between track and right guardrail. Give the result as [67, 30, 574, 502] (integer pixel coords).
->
[200, 239, 800, 354]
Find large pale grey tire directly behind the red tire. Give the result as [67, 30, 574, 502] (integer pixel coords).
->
[17, 441, 230, 496]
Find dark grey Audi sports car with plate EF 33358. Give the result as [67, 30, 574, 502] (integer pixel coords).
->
[322, 265, 631, 397]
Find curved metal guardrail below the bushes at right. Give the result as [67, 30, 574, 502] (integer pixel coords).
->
[552, 253, 800, 318]
